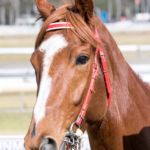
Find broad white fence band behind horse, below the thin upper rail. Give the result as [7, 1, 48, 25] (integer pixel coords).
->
[0, 64, 150, 93]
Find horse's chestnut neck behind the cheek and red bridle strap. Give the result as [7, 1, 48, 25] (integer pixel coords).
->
[88, 24, 150, 150]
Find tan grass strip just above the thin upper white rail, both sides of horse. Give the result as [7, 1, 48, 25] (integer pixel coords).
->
[0, 32, 150, 47]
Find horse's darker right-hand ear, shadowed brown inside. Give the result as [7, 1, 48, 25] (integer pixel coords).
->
[75, 0, 94, 22]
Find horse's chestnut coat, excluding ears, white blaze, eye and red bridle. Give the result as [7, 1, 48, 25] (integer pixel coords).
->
[25, 1, 150, 150]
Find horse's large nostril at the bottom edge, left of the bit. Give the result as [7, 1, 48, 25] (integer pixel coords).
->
[39, 138, 57, 150]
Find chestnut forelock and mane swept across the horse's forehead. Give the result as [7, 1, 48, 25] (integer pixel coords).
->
[35, 4, 100, 49]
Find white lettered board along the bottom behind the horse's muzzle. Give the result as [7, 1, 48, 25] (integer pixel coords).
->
[0, 134, 90, 150]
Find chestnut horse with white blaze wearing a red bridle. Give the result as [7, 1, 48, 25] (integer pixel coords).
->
[24, 0, 150, 150]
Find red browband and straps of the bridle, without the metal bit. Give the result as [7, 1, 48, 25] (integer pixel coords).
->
[46, 22, 112, 126]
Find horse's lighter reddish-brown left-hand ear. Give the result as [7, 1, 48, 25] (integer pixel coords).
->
[35, 0, 55, 19]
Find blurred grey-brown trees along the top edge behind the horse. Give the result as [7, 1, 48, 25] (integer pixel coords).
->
[0, 0, 150, 24]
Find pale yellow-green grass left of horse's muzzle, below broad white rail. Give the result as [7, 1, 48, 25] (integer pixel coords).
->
[0, 92, 36, 135]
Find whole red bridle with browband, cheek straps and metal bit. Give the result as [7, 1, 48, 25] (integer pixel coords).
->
[46, 22, 112, 150]
